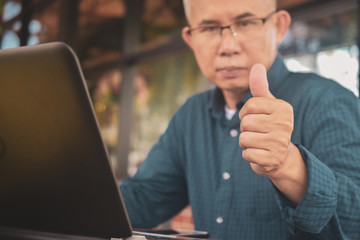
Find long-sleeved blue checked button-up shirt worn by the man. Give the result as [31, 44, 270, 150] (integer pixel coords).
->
[120, 56, 360, 240]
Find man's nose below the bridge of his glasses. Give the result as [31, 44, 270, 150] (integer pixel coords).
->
[218, 26, 241, 56]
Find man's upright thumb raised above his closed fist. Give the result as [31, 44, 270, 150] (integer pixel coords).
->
[249, 63, 275, 98]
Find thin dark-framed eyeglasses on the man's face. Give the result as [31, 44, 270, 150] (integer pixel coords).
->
[188, 10, 277, 41]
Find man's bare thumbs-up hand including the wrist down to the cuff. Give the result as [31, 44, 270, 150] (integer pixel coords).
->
[239, 64, 307, 205]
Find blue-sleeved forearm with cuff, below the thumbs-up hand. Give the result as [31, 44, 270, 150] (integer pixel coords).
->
[277, 146, 360, 240]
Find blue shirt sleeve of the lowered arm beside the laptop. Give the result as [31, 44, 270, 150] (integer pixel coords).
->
[120, 109, 188, 228]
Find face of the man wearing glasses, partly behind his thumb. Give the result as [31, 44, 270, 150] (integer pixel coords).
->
[183, 0, 280, 92]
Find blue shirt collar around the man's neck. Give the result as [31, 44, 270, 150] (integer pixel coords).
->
[208, 54, 289, 118]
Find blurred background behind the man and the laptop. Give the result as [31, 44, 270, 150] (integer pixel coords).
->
[0, 0, 360, 229]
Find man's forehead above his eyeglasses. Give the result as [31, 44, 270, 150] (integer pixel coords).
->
[187, 0, 276, 25]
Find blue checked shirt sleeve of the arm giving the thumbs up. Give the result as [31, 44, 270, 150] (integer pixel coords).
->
[276, 83, 360, 240]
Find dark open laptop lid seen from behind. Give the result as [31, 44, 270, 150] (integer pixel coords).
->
[0, 43, 131, 238]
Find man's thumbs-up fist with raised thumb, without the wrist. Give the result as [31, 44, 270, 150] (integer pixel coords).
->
[239, 64, 296, 179]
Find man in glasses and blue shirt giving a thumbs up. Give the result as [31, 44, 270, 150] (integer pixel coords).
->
[121, 0, 360, 239]
